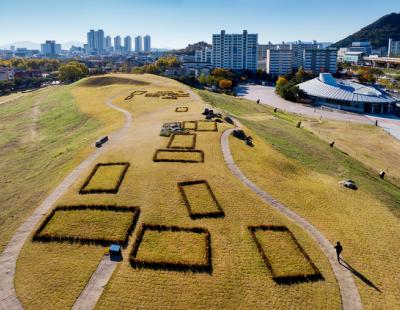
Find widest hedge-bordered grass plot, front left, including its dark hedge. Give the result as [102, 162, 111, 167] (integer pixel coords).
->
[32, 205, 140, 246]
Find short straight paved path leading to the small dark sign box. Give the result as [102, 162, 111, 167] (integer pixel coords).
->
[72, 256, 118, 310]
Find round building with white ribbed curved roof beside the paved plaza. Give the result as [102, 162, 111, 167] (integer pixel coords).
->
[298, 73, 398, 113]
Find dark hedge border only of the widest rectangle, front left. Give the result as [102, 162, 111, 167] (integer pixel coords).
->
[32, 205, 140, 248]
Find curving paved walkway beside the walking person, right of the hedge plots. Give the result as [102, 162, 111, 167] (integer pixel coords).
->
[221, 122, 362, 310]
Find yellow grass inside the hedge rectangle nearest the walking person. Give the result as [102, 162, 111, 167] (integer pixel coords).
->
[254, 229, 316, 278]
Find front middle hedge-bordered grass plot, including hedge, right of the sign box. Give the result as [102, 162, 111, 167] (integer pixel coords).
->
[129, 224, 212, 273]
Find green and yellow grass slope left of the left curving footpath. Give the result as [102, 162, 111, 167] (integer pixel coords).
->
[0, 75, 145, 252]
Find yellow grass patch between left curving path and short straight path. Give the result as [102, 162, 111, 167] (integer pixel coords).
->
[15, 242, 105, 309]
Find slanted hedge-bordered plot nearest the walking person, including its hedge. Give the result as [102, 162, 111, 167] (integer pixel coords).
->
[249, 226, 323, 284]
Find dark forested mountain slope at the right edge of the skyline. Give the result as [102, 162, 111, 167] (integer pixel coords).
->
[334, 13, 400, 48]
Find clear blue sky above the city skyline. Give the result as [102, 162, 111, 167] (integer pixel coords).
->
[0, 0, 400, 47]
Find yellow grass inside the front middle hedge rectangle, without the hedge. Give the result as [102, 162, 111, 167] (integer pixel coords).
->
[135, 230, 207, 265]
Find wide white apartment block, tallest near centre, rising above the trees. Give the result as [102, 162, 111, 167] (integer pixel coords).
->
[212, 30, 258, 70]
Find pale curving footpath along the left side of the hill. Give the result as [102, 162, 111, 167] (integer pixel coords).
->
[0, 98, 132, 310]
